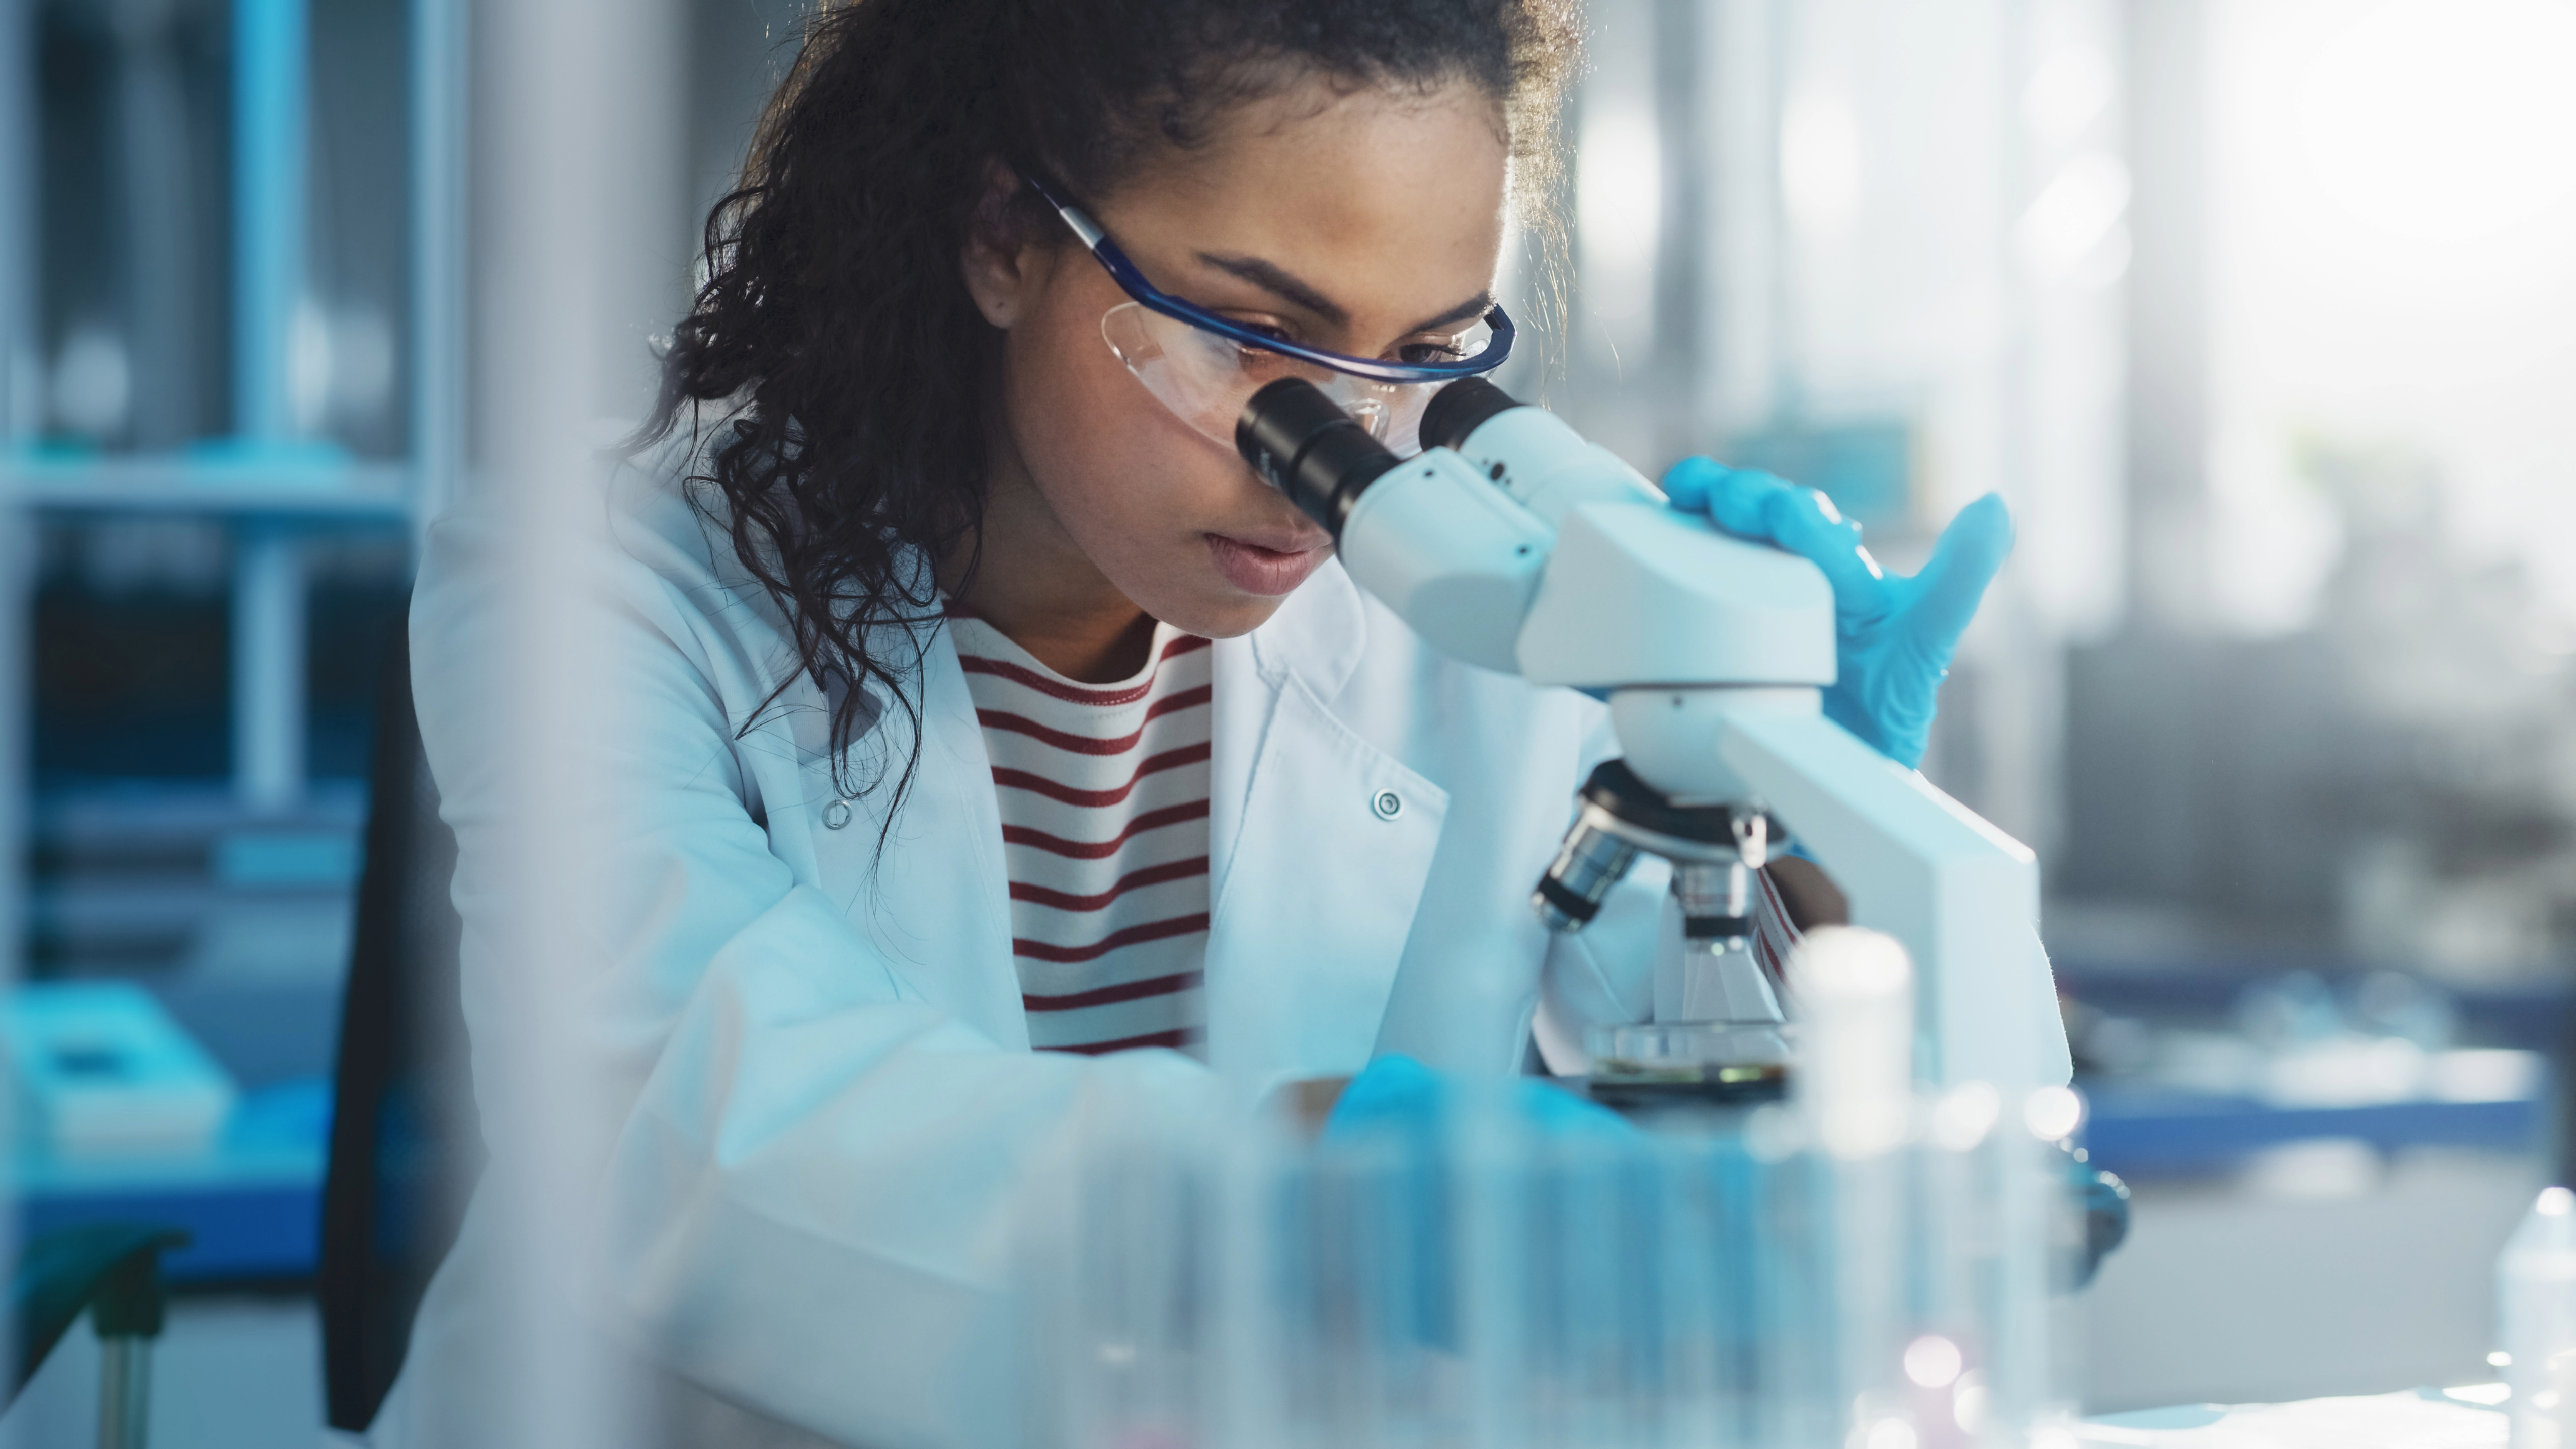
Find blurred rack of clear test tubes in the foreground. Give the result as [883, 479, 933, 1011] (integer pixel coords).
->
[1020, 928, 2081, 1449]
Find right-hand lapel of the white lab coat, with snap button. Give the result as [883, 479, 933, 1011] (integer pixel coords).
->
[1208, 678, 1447, 1080]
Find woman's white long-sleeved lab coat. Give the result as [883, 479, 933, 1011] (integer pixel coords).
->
[376, 433, 1664, 1449]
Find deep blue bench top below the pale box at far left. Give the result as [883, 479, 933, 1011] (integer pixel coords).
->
[18, 1080, 330, 1284]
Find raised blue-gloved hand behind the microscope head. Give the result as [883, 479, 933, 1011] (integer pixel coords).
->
[1664, 459, 2012, 768]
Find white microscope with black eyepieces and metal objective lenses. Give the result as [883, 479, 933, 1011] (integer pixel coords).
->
[1234, 379, 2066, 1098]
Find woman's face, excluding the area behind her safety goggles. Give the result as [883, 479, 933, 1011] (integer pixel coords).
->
[966, 83, 1507, 637]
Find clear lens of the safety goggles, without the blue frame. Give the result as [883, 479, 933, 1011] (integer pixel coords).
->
[1100, 302, 1494, 454]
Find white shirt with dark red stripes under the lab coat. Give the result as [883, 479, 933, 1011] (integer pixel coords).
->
[950, 616, 1214, 1052]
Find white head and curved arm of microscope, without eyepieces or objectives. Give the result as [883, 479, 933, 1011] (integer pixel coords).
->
[1342, 471, 2068, 1088]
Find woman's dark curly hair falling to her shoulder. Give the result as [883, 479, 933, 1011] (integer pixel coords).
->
[639, 0, 1582, 825]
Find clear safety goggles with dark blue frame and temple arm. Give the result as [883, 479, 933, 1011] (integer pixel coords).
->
[1020, 170, 1512, 454]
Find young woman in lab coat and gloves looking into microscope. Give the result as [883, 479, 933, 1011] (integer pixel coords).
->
[379, 0, 2045, 1446]
